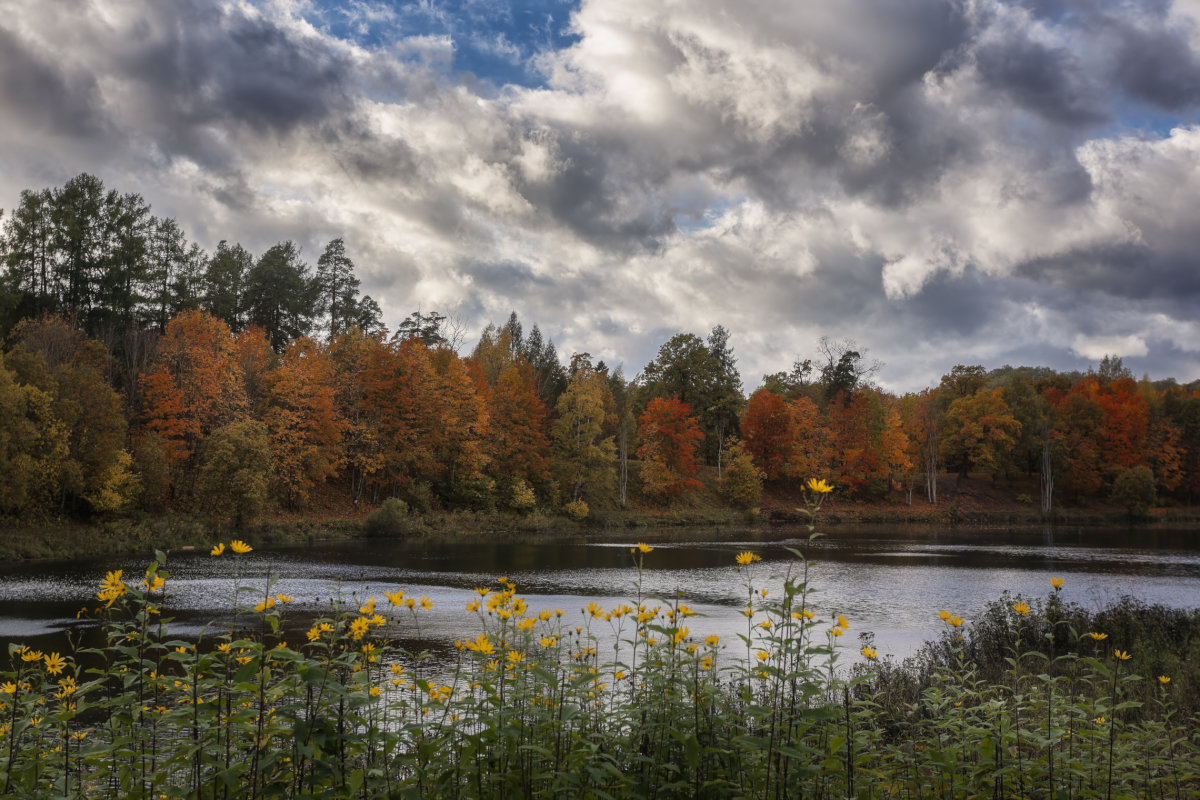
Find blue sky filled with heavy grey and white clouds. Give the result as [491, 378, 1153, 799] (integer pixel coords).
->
[0, 0, 1200, 391]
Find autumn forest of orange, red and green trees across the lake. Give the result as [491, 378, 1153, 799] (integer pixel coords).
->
[0, 174, 1200, 525]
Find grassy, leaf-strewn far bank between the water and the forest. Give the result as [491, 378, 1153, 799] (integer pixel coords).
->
[0, 468, 1200, 560]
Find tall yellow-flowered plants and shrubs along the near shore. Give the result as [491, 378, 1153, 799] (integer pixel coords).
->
[0, 496, 1200, 800]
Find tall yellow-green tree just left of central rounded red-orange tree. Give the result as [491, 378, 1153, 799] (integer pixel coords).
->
[551, 353, 617, 501]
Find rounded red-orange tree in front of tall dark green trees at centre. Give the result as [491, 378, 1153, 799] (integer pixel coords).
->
[637, 397, 704, 498]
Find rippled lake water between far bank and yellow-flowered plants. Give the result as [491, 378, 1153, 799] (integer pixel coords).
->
[0, 528, 1200, 657]
